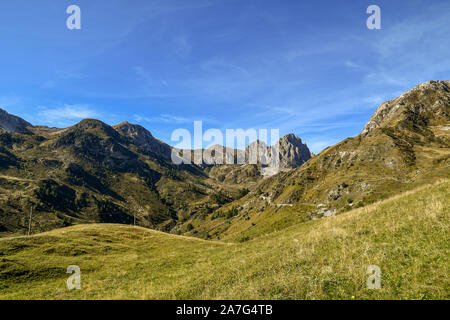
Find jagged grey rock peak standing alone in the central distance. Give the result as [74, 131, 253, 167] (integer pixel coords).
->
[278, 133, 311, 168]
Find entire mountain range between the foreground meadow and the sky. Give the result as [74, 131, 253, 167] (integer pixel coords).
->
[0, 81, 450, 241]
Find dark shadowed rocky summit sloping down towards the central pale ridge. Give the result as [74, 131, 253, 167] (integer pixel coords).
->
[114, 121, 172, 160]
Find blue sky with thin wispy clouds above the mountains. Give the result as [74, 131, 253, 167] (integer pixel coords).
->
[0, 0, 450, 152]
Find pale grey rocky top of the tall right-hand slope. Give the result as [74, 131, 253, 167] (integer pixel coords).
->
[361, 80, 450, 136]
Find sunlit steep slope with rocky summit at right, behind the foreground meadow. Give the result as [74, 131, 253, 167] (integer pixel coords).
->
[195, 81, 450, 241]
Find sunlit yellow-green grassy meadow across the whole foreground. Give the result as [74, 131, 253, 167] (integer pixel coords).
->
[0, 180, 450, 299]
